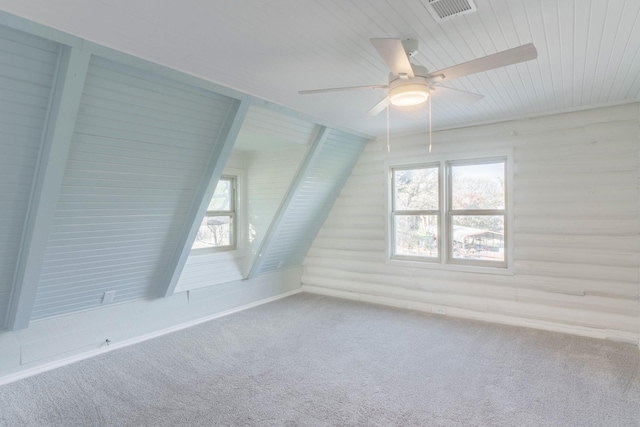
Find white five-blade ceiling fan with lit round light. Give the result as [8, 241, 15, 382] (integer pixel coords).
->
[298, 38, 538, 116]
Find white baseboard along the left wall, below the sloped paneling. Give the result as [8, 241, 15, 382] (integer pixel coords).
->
[0, 289, 302, 386]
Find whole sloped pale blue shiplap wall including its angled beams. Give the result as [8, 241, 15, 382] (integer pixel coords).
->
[0, 16, 369, 330]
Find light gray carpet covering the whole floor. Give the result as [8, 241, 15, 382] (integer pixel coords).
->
[0, 294, 640, 427]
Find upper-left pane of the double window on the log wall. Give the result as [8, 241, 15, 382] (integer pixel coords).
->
[393, 167, 439, 211]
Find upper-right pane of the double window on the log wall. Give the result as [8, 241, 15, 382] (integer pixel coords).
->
[451, 162, 505, 210]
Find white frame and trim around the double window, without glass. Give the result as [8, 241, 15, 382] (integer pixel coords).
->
[385, 149, 514, 275]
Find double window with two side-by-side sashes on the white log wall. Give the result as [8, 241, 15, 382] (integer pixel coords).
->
[390, 157, 508, 268]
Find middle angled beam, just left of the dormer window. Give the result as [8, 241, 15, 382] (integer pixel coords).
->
[159, 99, 251, 297]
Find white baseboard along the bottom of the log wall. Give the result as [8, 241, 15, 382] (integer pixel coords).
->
[302, 284, 640, 349]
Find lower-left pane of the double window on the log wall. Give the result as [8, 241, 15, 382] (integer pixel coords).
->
[394, 215, 438, 257]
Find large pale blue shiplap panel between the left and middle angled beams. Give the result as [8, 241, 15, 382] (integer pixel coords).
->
[32, 57, 231, 319]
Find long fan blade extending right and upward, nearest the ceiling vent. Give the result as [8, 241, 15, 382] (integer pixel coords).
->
[427, 43, 538, 82]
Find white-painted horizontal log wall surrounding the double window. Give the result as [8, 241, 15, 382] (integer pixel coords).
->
[302, 104, 640, 339]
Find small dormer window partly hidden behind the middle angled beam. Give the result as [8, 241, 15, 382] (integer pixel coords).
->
[192, 176, 237, 250]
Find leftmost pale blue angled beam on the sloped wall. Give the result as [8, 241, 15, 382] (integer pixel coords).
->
[6, 46, 91, 330]
